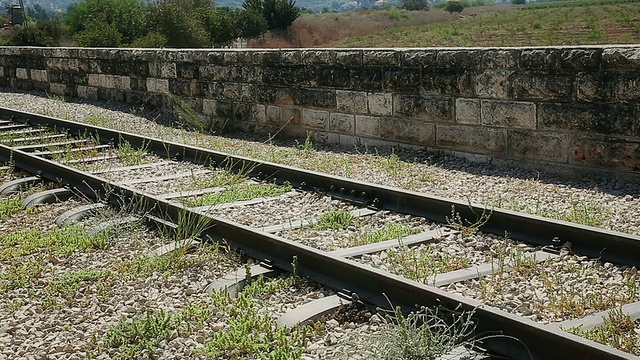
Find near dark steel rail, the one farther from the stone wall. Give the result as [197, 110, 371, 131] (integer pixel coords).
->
[0, 145, 640, 360]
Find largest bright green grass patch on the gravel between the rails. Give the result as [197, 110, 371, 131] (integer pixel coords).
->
[182, 184, 292, 207]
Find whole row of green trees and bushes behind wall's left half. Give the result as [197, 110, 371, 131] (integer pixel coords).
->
[5, 0, 300, 48]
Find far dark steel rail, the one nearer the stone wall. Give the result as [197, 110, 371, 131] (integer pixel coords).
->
[0, 107, 640, 267]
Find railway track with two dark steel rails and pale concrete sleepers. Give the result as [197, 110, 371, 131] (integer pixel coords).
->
[0, 109, 640, 359]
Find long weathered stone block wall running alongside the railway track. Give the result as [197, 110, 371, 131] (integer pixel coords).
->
[0, 46, 640, 174]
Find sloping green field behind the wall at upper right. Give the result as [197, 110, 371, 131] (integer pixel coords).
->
[332, 0, 640, 47]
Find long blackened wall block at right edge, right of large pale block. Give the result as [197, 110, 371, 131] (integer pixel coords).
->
[538, 103, 638, 136]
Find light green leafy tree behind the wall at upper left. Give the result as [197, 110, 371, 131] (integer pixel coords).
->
[65, 0, 144, 46]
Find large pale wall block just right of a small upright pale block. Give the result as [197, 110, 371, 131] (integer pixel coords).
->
[482, 100, 536, 129]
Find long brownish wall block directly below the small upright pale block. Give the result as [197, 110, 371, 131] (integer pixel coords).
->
[436, 124, 508, 155]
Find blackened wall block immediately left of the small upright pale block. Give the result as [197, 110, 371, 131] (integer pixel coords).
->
[393, 95, 453, 122]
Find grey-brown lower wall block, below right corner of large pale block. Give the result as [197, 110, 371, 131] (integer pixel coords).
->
[509, 130, 569, 163]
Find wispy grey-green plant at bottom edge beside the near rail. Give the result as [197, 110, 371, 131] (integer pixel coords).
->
[372, 300, 476, 360]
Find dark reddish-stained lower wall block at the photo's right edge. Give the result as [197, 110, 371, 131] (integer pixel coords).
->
[569, 135, 640, 172]
